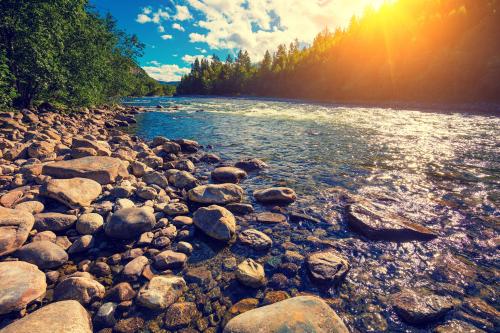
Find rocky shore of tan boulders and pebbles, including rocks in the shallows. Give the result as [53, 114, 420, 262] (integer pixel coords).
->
[0, 107, 499, 333]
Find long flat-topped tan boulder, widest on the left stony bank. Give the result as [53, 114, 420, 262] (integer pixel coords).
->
[42, 156, 128, 184]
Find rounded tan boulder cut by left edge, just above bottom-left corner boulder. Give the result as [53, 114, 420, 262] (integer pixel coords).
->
[0, 261, 47, 315]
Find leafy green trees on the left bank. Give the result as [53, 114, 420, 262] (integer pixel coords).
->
[0, 0, 169, 107]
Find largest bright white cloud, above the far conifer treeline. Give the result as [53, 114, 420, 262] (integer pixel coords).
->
[186, 0, 382, 60]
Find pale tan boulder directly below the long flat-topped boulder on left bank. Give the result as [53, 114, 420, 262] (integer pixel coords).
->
[40, 178, 102, 208]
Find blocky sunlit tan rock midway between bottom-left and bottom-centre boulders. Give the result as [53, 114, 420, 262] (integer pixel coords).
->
[137, 276, 186, 310]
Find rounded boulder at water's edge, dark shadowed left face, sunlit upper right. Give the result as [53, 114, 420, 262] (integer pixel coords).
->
[193, 205, 236, 241]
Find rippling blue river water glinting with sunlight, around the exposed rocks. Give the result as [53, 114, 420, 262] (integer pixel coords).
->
[125, 98, 500, 332]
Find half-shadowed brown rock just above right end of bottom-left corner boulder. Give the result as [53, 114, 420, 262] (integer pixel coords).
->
[54, 273, 105, 305]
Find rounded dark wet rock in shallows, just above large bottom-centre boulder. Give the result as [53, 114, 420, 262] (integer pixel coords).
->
[307, 250, 350, 283]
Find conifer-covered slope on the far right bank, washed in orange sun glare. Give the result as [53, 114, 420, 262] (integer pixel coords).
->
[177, 0, 500, 102]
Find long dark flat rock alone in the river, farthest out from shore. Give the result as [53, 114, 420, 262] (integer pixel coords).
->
[347, 201, 437, 242]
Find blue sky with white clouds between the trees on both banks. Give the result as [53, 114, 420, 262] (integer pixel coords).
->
[90, 0, 384, 81]
